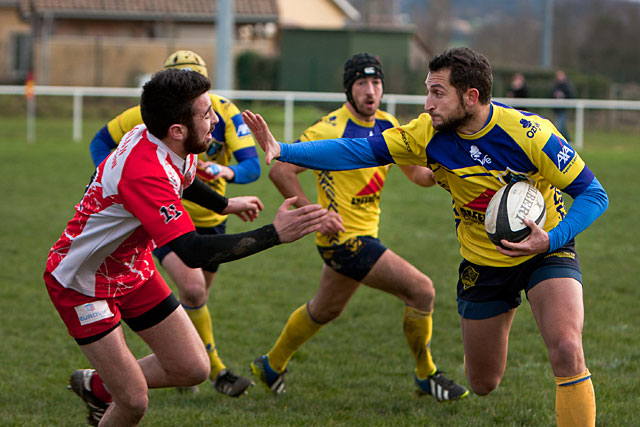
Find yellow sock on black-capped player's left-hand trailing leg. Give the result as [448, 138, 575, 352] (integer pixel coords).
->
[267, 304, 323, 372]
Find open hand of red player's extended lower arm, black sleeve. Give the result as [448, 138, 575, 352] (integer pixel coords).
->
[273, 197, 327, 243]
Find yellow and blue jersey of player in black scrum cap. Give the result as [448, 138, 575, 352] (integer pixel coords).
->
[300, 105, 398, 246]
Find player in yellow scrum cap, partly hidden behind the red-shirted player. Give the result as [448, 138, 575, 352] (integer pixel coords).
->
[90, 50, 260, 397]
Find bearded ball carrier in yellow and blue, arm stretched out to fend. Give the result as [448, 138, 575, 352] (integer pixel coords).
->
[243, 48, 609, 427]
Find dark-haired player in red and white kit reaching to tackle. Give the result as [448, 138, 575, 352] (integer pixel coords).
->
[49, 69, 326, 426]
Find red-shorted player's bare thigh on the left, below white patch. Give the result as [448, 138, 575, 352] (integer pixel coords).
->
[80, 326, 147, 401]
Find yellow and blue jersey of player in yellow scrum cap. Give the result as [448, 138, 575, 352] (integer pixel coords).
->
[91, 93, 260, 227]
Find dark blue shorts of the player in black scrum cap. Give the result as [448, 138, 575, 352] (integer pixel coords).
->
[318, 236, 387, 282]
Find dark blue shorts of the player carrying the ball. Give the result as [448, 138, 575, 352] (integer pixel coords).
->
[458, 240, 582, 319]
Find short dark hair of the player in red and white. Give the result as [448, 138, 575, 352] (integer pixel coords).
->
[140, 68, 211, 138]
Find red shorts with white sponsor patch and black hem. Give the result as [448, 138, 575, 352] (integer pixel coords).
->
[44, 271, 178, 344]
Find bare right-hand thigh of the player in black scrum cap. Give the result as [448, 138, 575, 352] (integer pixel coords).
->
[363, 249, 435, 309]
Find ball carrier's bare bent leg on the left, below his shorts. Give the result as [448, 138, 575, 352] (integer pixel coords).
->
[460, 308, 516, 387]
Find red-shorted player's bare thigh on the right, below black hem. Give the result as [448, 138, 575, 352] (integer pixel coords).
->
[137, 306, 209, 373]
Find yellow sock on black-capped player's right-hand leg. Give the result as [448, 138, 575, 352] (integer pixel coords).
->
[402, 306, 436, 379]
